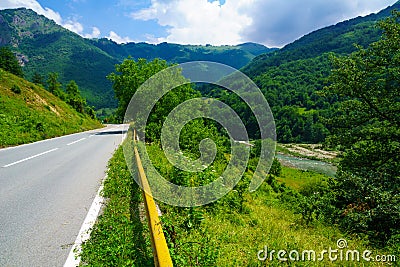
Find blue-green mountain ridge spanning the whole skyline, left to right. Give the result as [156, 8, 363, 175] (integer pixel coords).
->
[0, 1, 400, 108]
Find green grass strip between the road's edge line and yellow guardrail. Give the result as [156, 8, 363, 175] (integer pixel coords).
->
[81, 147, 153, 266]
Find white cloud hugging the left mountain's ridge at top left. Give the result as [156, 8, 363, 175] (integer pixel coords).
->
[0, 0, 100, 38]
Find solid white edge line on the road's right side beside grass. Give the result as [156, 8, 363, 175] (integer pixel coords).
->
[64, 177, 107, 267]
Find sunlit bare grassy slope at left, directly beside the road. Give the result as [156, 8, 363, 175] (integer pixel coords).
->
[0, 69, 101, 147]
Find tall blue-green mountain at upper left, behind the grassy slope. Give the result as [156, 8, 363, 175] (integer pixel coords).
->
[0, 8, 117, 107]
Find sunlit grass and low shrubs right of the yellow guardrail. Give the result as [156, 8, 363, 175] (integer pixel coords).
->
[148, 145, 376, 266]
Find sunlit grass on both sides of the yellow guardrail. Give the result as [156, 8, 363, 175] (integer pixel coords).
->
[83, 143, 394, 266]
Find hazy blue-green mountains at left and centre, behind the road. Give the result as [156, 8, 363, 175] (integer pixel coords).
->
[0, 8, 273, 108]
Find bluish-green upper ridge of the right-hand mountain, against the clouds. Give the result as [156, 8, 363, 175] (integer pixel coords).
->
[243, 1, 400, 77]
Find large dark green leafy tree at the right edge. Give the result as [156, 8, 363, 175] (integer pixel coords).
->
[326, 12, 400, 248]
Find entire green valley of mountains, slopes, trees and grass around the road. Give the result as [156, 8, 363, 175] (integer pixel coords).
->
[0, 1, 400, 266]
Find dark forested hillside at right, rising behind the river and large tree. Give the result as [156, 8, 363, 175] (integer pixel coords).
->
[226, 2, 400, 142]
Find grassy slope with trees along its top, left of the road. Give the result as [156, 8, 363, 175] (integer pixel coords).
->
[0, 44, 102, 148]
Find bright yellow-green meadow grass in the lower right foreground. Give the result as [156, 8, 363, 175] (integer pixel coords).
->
[157, 171, 382, 266]
